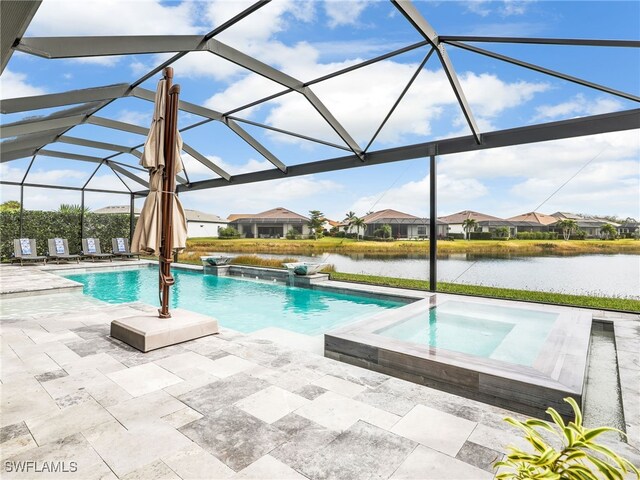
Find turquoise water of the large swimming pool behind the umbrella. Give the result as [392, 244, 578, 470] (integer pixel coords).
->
[65, 268, 405, 335]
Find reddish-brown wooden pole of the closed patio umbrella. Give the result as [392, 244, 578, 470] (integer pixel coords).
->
[158, 67, 180, 318]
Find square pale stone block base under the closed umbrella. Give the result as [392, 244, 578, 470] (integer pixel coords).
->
[111, 308, 219, 352]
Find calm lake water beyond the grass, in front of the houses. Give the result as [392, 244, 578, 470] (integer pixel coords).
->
[216, 253, 640, 299]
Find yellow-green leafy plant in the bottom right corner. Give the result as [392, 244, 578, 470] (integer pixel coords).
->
[495, 397, 640, 480]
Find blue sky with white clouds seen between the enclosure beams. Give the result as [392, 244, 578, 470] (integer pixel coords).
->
[0, 0, 640, 219]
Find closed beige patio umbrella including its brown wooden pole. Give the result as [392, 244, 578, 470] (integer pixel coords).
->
[131, 67, 187, 318]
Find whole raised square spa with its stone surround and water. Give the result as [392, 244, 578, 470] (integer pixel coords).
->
[325, 294, 592, 417]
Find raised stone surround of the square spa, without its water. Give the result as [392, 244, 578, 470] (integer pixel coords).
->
[325, 293, 592, 417]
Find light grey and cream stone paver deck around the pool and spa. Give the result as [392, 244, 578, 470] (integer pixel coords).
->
[0, 261, 640, 480]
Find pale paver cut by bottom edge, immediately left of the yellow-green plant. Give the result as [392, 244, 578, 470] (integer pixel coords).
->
[390, 445, 493, 480]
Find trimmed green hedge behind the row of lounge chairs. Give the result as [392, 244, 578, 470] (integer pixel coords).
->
[0, 210, 135, 258]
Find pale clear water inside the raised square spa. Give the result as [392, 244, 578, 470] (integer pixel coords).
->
[375, 301, 558, 366]
